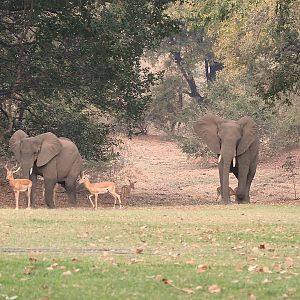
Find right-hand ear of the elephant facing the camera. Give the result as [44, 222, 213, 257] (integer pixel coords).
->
[237, 117, 258, 155]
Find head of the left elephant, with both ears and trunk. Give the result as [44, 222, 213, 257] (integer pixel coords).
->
[9, 130, 62, 178]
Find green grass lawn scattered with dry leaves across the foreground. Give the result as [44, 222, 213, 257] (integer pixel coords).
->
[0, 204, 300, 299]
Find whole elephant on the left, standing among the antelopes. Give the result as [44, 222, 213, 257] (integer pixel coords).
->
[9, 130, 82, 208]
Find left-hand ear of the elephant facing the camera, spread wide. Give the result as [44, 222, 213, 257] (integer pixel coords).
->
[194, 114, 224, 154]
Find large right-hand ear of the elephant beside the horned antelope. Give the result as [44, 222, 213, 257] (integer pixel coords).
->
[36, 132, 62, 167]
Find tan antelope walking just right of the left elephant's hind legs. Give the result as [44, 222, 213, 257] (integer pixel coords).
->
[79, 174, 122, 209]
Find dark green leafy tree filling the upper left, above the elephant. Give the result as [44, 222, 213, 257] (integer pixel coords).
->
[0, 0, 175, 158]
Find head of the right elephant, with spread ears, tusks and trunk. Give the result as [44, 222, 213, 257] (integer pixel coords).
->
[194, 114, 258, 202]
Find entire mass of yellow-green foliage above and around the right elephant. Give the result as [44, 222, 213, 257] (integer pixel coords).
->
[160, 0, 300, 155]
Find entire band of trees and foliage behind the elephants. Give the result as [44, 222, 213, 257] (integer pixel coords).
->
[0, 0, 300, 160]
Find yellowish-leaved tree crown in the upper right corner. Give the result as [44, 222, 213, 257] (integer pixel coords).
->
[202, 0, 300, 104]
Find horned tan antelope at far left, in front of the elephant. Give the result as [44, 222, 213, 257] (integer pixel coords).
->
[4, 163, 32, 209]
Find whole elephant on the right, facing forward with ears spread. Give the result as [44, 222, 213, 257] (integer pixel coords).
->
[194, 114, 259, 203]
